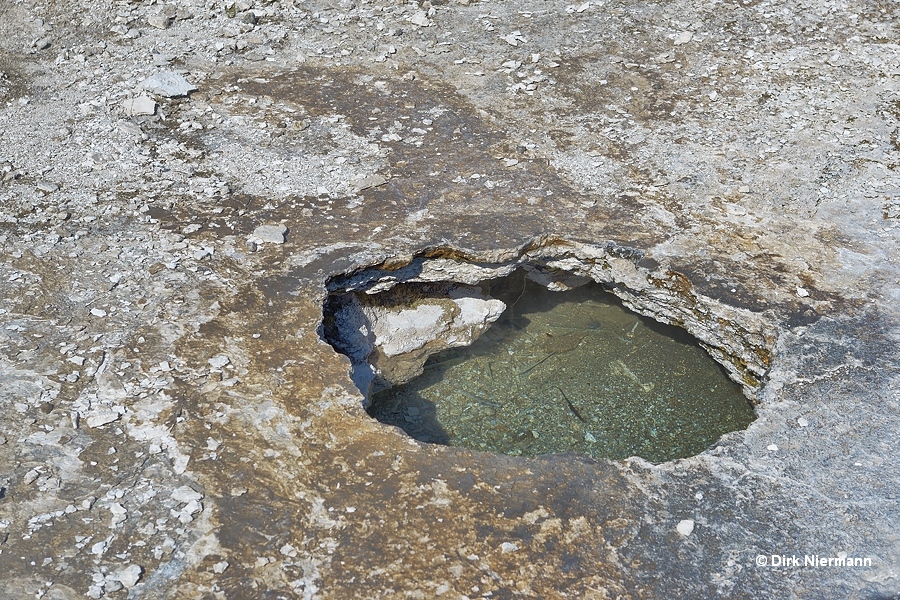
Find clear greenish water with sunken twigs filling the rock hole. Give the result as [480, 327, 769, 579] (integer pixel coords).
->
[369, 273, 755, 462]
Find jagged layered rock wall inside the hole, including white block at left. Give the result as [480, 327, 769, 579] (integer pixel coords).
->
[322, 236, 778, 399]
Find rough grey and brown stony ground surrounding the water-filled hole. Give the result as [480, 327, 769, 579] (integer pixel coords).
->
[0, 0, 900, 599]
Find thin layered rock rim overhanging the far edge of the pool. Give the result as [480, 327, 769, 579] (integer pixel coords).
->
[325, 236, 780, 398]
